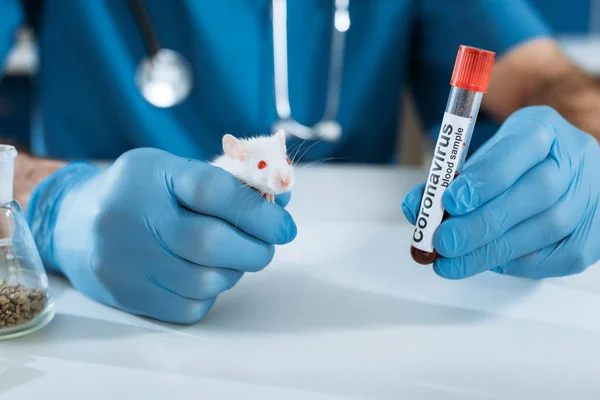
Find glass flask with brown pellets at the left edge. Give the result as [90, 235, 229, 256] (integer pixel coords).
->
[0, 145, 54, 340]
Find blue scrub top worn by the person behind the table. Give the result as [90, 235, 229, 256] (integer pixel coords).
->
[0, 0, 548, 163]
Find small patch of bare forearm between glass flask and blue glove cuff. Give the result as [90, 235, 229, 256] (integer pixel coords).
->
[9, 145, 65, 210]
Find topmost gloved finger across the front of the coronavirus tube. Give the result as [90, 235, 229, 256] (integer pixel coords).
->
[443, 118, 555, 215]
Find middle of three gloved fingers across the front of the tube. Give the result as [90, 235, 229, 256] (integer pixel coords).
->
[434, 159, 569, 258]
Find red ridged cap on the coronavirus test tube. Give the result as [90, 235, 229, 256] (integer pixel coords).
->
[450, 45, 496, 93]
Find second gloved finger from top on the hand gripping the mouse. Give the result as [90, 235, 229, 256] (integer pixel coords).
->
[156, 209, 275, 272]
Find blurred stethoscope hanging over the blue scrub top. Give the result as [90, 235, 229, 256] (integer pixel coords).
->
[129, 0, 350, 141]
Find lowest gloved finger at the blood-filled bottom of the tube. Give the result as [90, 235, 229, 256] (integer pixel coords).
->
[434, 194, 583, 279]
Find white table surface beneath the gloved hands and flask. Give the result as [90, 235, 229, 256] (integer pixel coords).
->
[0, 167, 600, 400]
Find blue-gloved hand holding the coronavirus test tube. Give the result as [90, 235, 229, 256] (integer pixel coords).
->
[402, 106, 600, 279]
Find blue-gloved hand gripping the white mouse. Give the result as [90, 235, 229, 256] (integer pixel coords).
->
[28, 149, 296, 323]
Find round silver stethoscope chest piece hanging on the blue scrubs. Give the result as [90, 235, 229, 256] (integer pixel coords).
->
[135, 48, 193, 108]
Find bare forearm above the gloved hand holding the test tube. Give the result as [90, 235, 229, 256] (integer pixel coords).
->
[484, 40, 600, 140]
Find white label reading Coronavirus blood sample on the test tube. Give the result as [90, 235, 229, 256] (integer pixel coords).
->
[412, 112, 471, 252]
